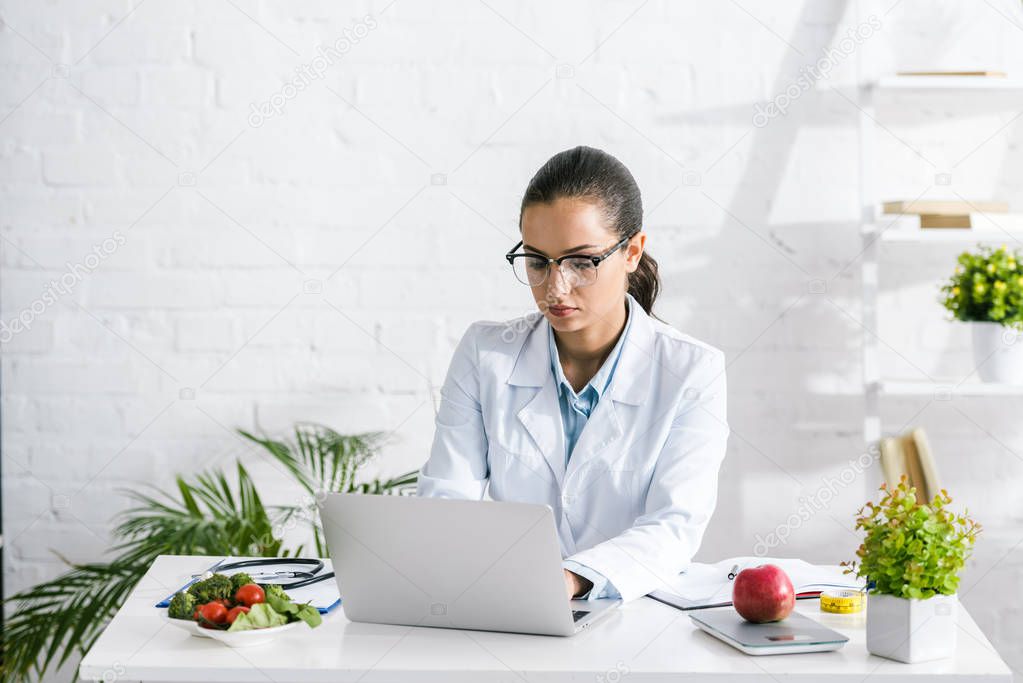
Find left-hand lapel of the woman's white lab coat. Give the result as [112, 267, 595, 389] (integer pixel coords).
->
[507, 315, 565, 488]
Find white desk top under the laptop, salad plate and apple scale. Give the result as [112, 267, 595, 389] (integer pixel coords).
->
[81, 556, 1012, 683]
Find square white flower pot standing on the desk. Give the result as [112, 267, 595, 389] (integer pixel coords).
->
[866, 593, 959, 663]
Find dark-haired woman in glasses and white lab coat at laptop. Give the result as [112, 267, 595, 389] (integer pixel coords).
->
[418, 147, 729, 600]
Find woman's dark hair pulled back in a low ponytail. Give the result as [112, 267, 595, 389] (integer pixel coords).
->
[519, 145, 661, 317]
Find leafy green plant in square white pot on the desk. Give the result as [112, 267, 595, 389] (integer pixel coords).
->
[843, 475, 980, 663]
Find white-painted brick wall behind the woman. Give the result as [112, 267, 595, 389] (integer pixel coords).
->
[0, 0, 1023, 669]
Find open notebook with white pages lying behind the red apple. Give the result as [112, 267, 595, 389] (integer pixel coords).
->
[650, 556, 865, 609]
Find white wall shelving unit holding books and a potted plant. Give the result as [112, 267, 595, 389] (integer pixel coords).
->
[858, 76, 1023, 446]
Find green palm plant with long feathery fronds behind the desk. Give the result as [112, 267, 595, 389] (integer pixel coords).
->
[0, 423, 418, 681]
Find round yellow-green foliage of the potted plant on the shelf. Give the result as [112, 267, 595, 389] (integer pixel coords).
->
[941, 245, 1023, 331]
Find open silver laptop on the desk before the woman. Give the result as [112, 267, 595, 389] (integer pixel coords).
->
[319, 494, 621, 636]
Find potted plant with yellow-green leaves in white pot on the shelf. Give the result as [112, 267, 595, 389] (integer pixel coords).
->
[941, 245, 1023, 384]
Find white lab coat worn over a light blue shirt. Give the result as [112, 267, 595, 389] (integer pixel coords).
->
[417, 293, 729, 600]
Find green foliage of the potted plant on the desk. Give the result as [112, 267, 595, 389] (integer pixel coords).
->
[842, 475, 981, 599]
